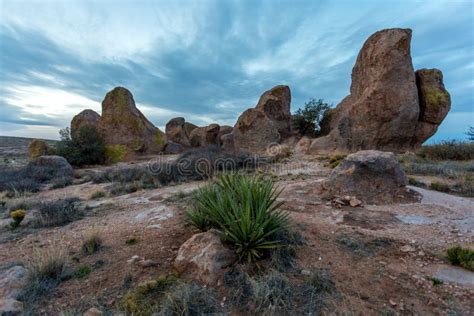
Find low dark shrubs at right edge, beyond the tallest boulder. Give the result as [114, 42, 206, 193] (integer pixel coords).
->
[417, 140, 474, 160]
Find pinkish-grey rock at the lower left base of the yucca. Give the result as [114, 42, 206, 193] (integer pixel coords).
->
[174, 232, 235, 284]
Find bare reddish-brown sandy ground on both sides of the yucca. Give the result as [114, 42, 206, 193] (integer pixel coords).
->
[0, 158, 474, 315]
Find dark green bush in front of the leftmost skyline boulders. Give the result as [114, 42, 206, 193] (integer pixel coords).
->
[56, 126, 105, 166]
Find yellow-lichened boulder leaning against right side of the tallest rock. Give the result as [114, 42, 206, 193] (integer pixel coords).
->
[413, 69, 451, 147]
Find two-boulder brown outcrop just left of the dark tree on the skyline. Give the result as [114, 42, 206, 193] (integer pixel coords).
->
[225, 86, 291, 154]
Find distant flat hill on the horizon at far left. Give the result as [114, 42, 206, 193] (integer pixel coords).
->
[0, 136, 57, 166]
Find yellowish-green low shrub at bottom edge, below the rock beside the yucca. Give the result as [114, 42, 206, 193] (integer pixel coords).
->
[119, 275, 177, 316]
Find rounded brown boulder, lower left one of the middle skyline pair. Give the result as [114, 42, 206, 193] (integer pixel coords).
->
[232, 109, 280, 154]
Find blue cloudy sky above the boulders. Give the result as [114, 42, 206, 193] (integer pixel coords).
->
[0, 0, 474, 141]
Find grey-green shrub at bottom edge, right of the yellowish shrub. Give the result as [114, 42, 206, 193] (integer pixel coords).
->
[158, 282, 219, 316]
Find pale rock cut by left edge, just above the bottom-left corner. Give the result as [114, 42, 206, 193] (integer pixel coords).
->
[0, 266, 28, 299]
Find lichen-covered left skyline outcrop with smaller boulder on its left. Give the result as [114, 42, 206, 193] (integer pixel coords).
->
[71, 87, 166, 154]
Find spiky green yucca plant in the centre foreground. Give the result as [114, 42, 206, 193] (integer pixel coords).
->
[188, 173, 288, 261]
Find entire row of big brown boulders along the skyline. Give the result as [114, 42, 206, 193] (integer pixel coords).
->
[62, 29, 451, 162]
